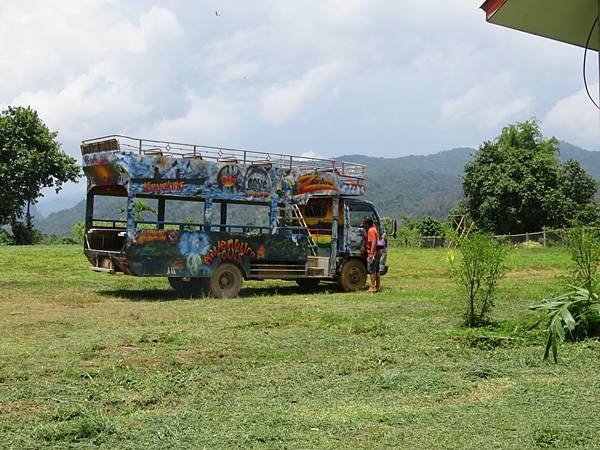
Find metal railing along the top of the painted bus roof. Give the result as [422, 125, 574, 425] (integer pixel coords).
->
[81, 134, 366, 179]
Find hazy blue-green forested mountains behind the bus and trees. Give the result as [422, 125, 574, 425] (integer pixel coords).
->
[35, 142, 600, 236]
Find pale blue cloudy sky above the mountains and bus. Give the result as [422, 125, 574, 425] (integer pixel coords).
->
[0, 0, 600, 210]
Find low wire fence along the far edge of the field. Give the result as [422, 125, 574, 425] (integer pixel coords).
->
[388, 230, 580, 248]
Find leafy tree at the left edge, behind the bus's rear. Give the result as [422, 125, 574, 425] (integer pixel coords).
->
[0, 106, 79, 244]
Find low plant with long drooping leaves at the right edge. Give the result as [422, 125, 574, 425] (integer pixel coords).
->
[530, 286, 600, 363]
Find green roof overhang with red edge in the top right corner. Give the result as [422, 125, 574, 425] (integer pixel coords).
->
[481, 0, 600, 50]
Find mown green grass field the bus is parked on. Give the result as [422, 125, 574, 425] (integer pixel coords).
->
[0, 246, 600, 449]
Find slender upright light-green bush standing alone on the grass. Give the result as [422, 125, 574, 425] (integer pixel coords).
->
[448, 232, 507, 327]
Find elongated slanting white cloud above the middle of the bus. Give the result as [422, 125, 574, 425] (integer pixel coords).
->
[260, 62, 340, 126]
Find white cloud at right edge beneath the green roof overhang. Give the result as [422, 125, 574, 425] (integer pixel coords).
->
[543, 89, 600, 150]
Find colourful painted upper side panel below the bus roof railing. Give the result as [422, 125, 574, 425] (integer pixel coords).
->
[83, 151, 365, 202]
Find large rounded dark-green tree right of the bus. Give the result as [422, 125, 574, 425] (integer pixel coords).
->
[463, 120, 597, 234]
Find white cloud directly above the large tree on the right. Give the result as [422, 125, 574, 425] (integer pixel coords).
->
[441, 71, 533, 130]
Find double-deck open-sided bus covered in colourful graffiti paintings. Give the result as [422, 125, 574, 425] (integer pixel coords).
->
[81, 135, 387, 297]
